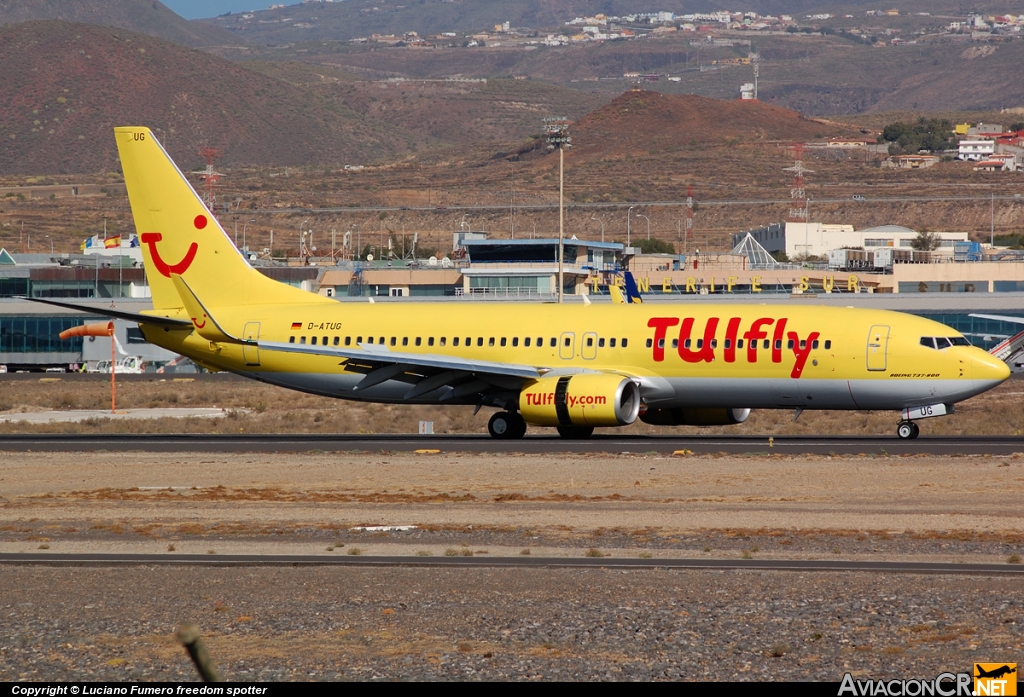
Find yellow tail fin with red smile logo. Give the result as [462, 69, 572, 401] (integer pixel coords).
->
[114, 126, 331, 309]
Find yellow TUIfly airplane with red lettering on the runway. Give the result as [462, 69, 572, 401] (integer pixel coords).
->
[34, 127, 1010, 438]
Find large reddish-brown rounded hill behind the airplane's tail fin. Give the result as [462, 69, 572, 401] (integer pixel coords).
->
[0, 20, 421, 174]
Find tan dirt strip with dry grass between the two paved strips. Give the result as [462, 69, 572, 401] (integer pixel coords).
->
[0, 452, 1024, 562]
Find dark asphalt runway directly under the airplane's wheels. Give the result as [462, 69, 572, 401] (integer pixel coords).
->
[0, 434, 1024, 455]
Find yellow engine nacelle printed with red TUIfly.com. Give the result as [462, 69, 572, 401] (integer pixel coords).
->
[519, 374, 640, 426]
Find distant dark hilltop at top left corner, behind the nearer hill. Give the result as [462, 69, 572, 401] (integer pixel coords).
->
[0, 0, 240, 47]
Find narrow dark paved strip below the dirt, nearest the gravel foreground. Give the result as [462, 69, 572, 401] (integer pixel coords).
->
[0, 553, 1024, 577]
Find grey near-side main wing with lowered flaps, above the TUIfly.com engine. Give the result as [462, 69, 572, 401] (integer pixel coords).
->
[253, 341, 548, 401]
